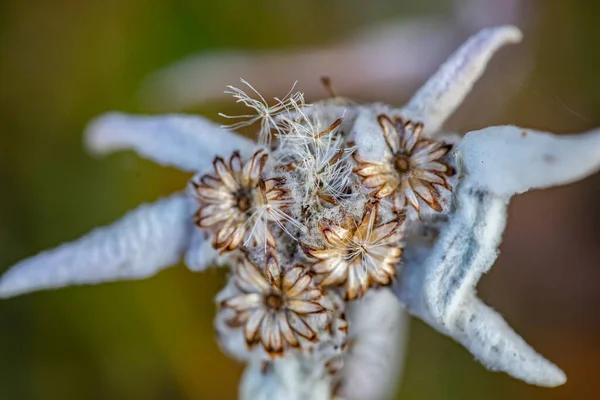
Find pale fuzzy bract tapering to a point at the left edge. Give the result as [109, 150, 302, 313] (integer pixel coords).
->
[0, 194, 196, 297]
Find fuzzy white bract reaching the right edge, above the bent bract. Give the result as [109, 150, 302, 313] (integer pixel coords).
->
[456, 126, 600, 197]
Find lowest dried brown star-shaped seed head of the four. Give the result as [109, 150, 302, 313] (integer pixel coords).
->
[221, 255, 331, 356]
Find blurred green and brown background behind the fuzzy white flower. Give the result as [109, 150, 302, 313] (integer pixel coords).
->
[0, 0, 600, 400]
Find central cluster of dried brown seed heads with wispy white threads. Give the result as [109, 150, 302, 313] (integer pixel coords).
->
[190, 81, 454, 374]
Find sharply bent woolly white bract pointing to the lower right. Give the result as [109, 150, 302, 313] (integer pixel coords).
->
[395, 182, 566, 386]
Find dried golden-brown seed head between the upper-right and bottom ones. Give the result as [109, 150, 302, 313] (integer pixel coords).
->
[302, 202, 404, 300]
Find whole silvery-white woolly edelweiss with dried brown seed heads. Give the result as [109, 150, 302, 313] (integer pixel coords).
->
[0, 26, 600, 399]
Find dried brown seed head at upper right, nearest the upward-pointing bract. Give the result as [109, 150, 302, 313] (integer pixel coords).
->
[354, 115, 454, 212]
